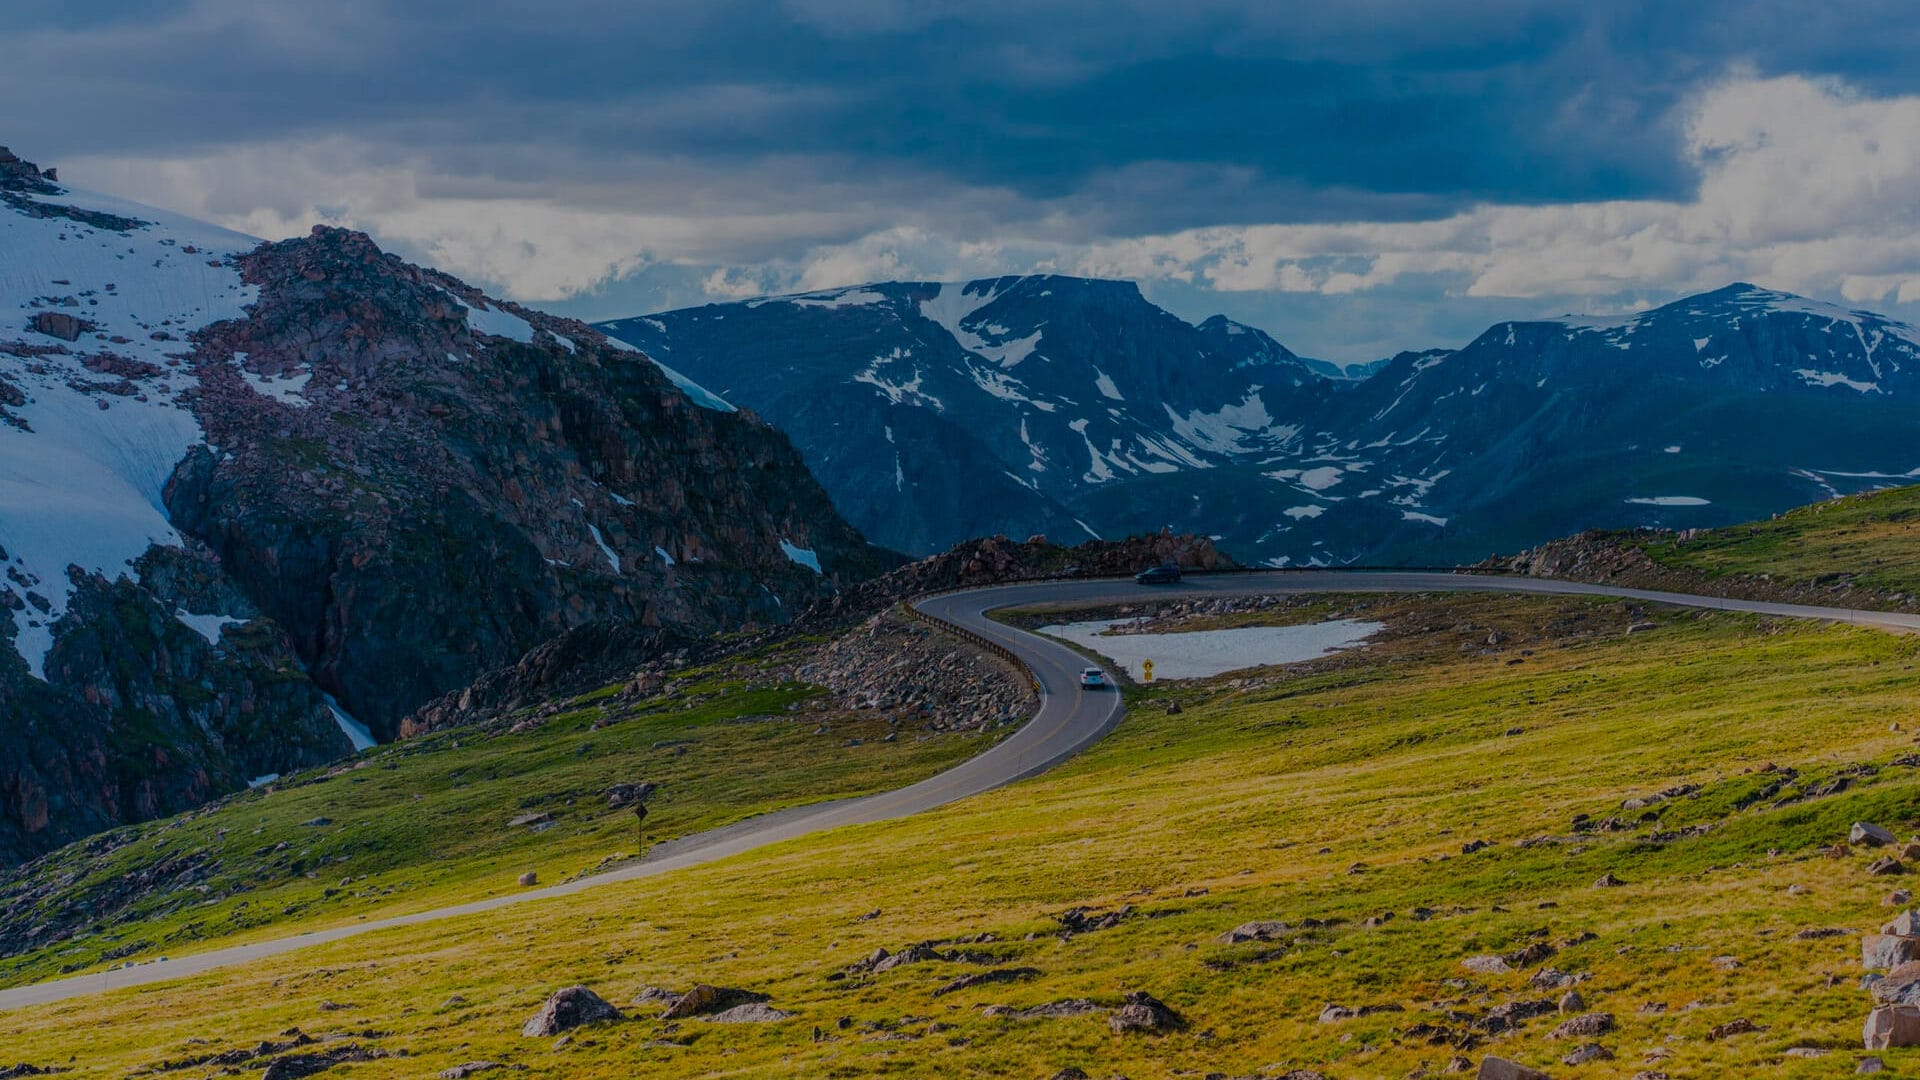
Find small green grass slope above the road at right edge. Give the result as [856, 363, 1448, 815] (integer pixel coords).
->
[1644, 486, 1920, 596]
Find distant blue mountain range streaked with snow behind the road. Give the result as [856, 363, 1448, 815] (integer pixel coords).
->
[605, 277, 1920, 565]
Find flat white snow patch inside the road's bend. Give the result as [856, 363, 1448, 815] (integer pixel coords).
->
[1041, 619, 1384, 680]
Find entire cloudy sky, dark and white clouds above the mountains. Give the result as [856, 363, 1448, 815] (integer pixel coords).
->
[0, 0, 1920, 361]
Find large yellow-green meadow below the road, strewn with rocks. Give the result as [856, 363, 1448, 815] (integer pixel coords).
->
[0, 598, 1920, 1080]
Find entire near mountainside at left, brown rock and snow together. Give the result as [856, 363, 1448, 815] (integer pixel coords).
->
[0, 152, 893, 861]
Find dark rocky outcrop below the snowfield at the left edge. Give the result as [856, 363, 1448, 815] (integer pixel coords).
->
[0, 557, 351, 857]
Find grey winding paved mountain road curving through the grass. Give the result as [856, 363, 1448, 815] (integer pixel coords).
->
[0, 571, 1920, 1011]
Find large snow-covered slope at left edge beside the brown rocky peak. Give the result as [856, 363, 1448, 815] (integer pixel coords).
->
[0, 190, 257, 678]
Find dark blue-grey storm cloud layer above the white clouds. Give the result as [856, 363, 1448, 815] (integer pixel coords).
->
[0, 0, 1920, 231]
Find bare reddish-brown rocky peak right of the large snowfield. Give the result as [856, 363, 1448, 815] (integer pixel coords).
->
[167, 221, 887, 738]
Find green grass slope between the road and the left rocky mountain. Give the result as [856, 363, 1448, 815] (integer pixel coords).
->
[0, 634, 1004, 991]
